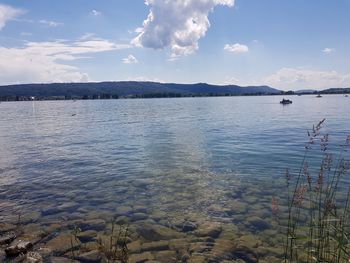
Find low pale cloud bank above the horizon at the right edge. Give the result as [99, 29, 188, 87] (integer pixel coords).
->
[262, 68, 350, 90]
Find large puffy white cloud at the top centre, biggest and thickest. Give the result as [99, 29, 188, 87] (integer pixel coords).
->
[132, 0, 234, 58]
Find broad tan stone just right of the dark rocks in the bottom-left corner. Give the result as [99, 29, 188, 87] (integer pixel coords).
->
[45, 233, 81, 255]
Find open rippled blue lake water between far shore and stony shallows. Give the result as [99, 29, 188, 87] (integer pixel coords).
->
[0, 95, 350, 262]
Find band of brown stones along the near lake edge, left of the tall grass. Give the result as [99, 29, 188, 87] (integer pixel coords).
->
[0, 203, 283, 263]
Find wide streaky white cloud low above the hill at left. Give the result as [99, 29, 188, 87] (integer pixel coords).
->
[0, 35, 130, 85]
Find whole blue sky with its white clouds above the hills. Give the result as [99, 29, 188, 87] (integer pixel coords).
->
[0, 0, 350, 90]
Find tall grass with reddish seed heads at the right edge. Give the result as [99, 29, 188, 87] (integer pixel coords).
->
[284, 120, 350, 263]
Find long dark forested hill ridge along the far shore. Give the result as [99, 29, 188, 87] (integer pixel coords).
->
[0, 81, 281, 100]
